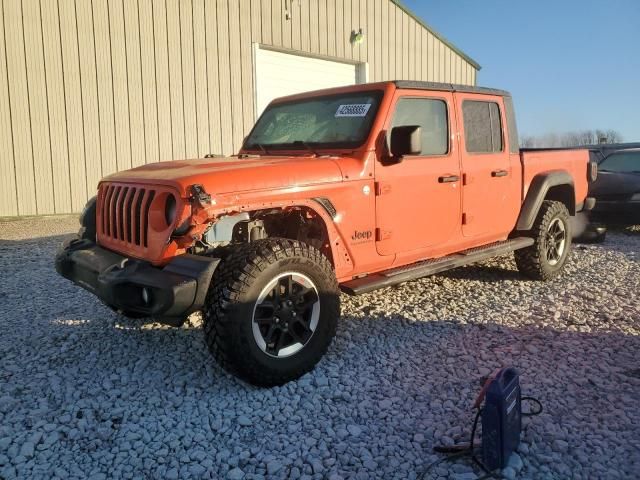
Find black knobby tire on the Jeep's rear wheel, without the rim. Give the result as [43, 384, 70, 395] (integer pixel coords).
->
[514, 200, 572, 280]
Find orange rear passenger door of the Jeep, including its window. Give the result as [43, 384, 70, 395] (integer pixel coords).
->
[455, 93, 520, 239]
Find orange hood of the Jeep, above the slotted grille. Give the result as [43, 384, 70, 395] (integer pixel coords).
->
[103, 156, 342, 195]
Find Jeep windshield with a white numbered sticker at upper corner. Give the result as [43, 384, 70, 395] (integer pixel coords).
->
[244, 91, 382, 151]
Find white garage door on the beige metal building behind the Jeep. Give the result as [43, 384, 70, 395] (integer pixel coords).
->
[256, 48, 359, 115]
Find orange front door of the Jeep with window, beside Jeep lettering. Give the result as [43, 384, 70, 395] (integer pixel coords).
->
[375, 91, 461, 255]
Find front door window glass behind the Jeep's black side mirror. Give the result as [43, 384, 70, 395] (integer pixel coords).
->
[387, 98, 449, 155]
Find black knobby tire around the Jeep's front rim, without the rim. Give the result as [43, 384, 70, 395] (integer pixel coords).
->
[203, 238, 340, 387]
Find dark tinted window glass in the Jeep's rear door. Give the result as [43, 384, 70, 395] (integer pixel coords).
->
[462, 100, 502, 153]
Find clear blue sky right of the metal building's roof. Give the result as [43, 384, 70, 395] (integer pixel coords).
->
[403, 0, 640, 141]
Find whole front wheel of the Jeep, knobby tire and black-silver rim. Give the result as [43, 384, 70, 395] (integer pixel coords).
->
[204, 239, 340, 386]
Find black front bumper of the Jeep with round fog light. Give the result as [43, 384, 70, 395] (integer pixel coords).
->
[56, 239, 220, 326]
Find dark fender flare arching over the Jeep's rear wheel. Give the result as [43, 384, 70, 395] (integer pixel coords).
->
[516, 170, 576, 230]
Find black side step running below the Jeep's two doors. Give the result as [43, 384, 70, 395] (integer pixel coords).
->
[340, 237, 534, 295]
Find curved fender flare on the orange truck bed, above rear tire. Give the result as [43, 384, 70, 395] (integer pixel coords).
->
[516, 170, 576, 231]
